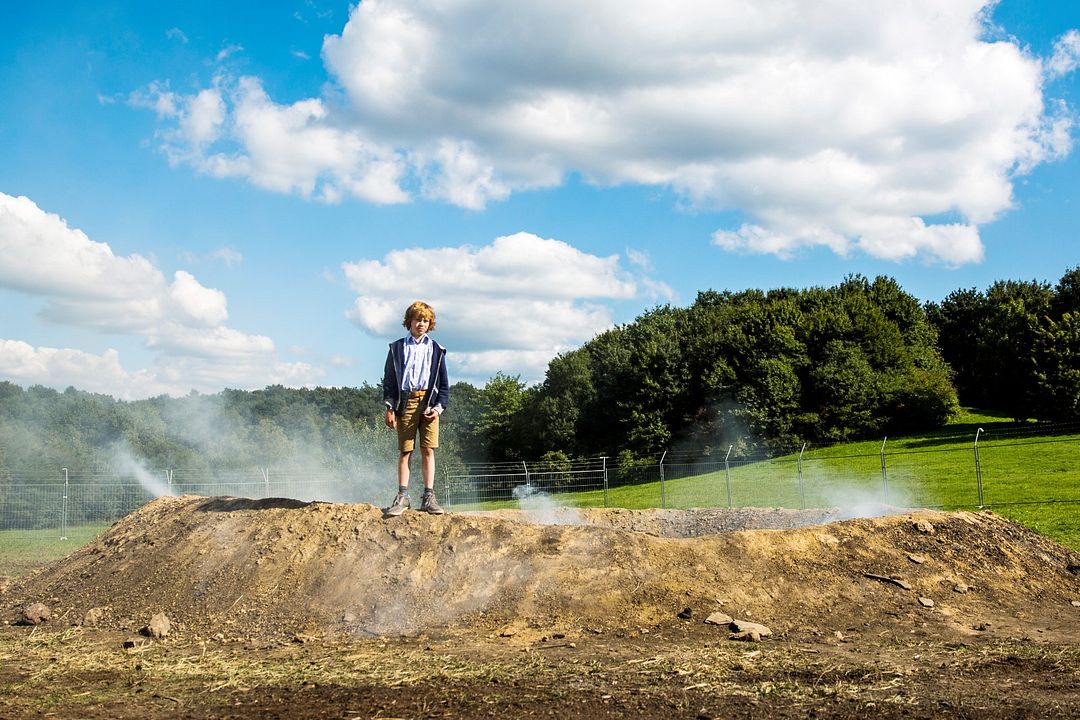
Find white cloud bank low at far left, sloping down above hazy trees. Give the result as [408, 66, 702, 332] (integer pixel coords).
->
[0, 193, 320, 398]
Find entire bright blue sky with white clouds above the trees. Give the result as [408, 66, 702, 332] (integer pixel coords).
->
[0, 0, 1080, 398]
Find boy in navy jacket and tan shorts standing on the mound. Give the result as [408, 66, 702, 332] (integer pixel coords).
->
[382, 300, 450, 516]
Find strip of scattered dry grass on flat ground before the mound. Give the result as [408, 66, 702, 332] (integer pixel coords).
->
[0, 627, 1080, 711]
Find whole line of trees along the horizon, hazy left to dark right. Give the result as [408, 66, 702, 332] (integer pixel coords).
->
[0, 269, 1080, 485]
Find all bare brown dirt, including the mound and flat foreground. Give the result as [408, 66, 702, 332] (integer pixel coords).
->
[0, 498, 1080, 720]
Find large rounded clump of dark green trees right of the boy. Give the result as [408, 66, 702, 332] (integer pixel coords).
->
[522, 275, 956, 457]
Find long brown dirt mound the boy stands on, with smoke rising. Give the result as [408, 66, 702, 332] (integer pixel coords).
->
[0, 498, 1080, 641]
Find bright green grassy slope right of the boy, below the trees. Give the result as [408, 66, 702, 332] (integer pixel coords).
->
[454, 410, 1080, 549]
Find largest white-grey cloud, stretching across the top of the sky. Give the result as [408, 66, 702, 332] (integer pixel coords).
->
[136, 0, 1080, 264]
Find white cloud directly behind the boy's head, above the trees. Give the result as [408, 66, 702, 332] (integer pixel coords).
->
[343, 232, 670, 381]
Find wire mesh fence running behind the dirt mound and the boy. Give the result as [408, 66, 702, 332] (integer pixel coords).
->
[0, 431, 1080, 546]
